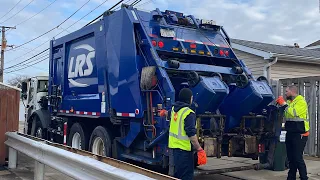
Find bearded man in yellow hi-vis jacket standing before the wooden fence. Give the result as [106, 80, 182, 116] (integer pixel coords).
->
[276, 85, 310, 180]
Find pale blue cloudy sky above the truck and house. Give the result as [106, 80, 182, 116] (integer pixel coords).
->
[0, 0, 320, 81]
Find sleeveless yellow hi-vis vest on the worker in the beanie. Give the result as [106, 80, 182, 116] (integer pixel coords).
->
[168, 107, 194, 151]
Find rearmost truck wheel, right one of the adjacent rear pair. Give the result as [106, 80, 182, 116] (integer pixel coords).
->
[90, 126, 111, 157]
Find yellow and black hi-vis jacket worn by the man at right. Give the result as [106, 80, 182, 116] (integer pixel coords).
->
[284, 95, 310, 133]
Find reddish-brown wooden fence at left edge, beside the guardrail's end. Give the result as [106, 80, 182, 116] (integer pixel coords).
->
[0, 83, 20, 166]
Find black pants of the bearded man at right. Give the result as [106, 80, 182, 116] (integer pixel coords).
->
[286, 132, 308, 180]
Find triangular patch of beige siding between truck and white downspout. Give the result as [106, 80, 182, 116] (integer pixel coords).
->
[233, 49, 268, 78]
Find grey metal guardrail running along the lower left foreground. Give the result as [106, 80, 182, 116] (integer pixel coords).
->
[5, 132, 178, 180]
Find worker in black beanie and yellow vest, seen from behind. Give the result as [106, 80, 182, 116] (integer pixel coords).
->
[160, 88, 207, 180]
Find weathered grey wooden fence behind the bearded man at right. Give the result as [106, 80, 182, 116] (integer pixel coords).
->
[271, 76, 320, 157]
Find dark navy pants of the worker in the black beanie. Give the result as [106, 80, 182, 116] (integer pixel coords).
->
[169, 149, 194, 180]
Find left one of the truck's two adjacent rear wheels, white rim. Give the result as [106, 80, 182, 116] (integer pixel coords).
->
[68, 123, 88, 150]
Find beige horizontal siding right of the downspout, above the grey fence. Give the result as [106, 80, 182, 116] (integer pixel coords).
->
[270, 59, 320, 80]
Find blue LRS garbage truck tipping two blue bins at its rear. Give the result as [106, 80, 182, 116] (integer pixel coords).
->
[23, 5, 275, 173]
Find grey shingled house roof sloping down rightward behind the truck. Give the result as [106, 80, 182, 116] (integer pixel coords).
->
[231, 39, 320, 58]
